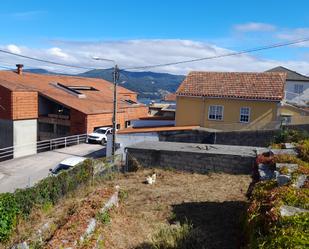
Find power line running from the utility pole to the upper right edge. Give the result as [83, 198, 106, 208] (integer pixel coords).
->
[123, 38, 309, 70]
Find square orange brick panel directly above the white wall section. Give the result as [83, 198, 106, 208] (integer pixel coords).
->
[12, 92, 38, 120]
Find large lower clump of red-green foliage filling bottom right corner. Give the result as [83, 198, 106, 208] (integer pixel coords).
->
[246, 181, 309, 249]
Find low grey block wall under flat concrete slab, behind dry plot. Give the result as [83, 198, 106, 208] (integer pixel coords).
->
[127, 148, 255, 174]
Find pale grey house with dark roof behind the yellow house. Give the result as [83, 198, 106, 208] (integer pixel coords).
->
[267, 66, 309, 104]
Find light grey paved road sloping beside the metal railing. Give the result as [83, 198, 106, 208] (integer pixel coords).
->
[0, 144, 105, 193]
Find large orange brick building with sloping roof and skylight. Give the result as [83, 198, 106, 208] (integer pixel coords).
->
[0, 65, 148, 157]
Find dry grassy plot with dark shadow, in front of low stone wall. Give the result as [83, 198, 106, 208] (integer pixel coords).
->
[102, 169, 251, 249]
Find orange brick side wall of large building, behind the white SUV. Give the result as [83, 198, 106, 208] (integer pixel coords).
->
[71, 106, 148, 134]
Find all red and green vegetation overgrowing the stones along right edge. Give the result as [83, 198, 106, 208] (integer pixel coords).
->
[245, 130, 309, 249]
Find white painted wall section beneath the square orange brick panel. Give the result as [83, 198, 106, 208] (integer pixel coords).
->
[13, 119, 37, 158]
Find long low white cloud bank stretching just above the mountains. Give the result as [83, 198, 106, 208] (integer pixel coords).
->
[0, 39, 309, 74]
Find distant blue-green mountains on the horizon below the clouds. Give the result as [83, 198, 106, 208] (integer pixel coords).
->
[24, 68, 185, 100]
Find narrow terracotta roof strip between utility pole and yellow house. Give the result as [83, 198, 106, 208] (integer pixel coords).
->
[117, 126, 200, 134]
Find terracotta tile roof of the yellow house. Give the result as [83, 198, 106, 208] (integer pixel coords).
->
[176, 72, 286, 101]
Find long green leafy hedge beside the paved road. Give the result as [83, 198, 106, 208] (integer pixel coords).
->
[0, 160, 93, 242]
